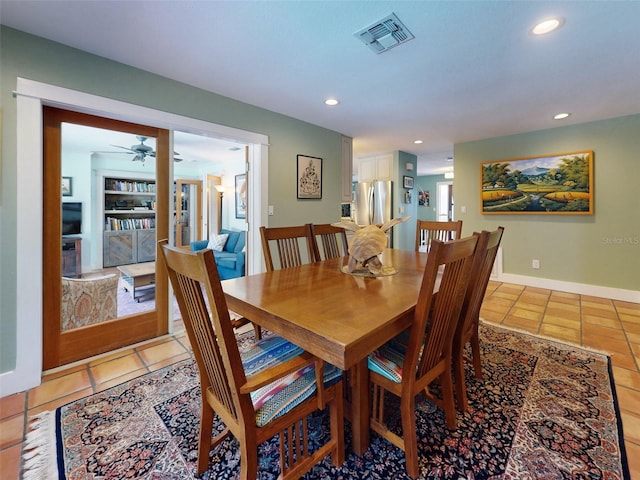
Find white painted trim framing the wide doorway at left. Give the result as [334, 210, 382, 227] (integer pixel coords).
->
[10, 78, 269, 393]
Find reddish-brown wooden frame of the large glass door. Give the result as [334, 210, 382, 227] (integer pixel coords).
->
[42, 106, 169, 370]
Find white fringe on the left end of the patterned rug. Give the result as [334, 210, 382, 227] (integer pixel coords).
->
[22, 411, 58, 480]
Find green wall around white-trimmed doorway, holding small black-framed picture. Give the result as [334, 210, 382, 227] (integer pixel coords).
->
[0, 26, 342, 373]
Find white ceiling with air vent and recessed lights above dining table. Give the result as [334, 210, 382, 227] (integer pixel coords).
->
[0, 0, 640, 174]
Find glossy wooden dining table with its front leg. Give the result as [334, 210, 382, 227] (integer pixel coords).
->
[222, 249, 427, 455]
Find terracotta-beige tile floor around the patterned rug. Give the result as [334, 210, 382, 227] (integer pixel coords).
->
[0, 282, 640, 480]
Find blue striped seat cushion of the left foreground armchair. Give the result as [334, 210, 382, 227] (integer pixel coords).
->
[241, 335, 342, 427]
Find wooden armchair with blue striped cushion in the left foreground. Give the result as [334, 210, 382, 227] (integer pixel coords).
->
[159, 240, 344, 480]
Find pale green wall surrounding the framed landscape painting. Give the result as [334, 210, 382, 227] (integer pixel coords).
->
[453, 115, 640, 291]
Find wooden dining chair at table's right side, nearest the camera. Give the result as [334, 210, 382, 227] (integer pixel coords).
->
[368, 236, 478, 479]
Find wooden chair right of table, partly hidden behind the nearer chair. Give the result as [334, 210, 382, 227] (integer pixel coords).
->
[453, 227, 504, 412]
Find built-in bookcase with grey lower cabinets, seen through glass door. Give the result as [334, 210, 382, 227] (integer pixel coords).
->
[102, 176, 156, 267]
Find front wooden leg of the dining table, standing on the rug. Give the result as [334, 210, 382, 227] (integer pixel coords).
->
[350, 357, 370, 455]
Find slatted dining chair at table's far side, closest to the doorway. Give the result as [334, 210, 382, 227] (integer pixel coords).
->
[260, 224, 315, 272]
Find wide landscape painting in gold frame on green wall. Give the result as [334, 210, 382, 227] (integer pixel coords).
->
[480, 150, 594, 215]
